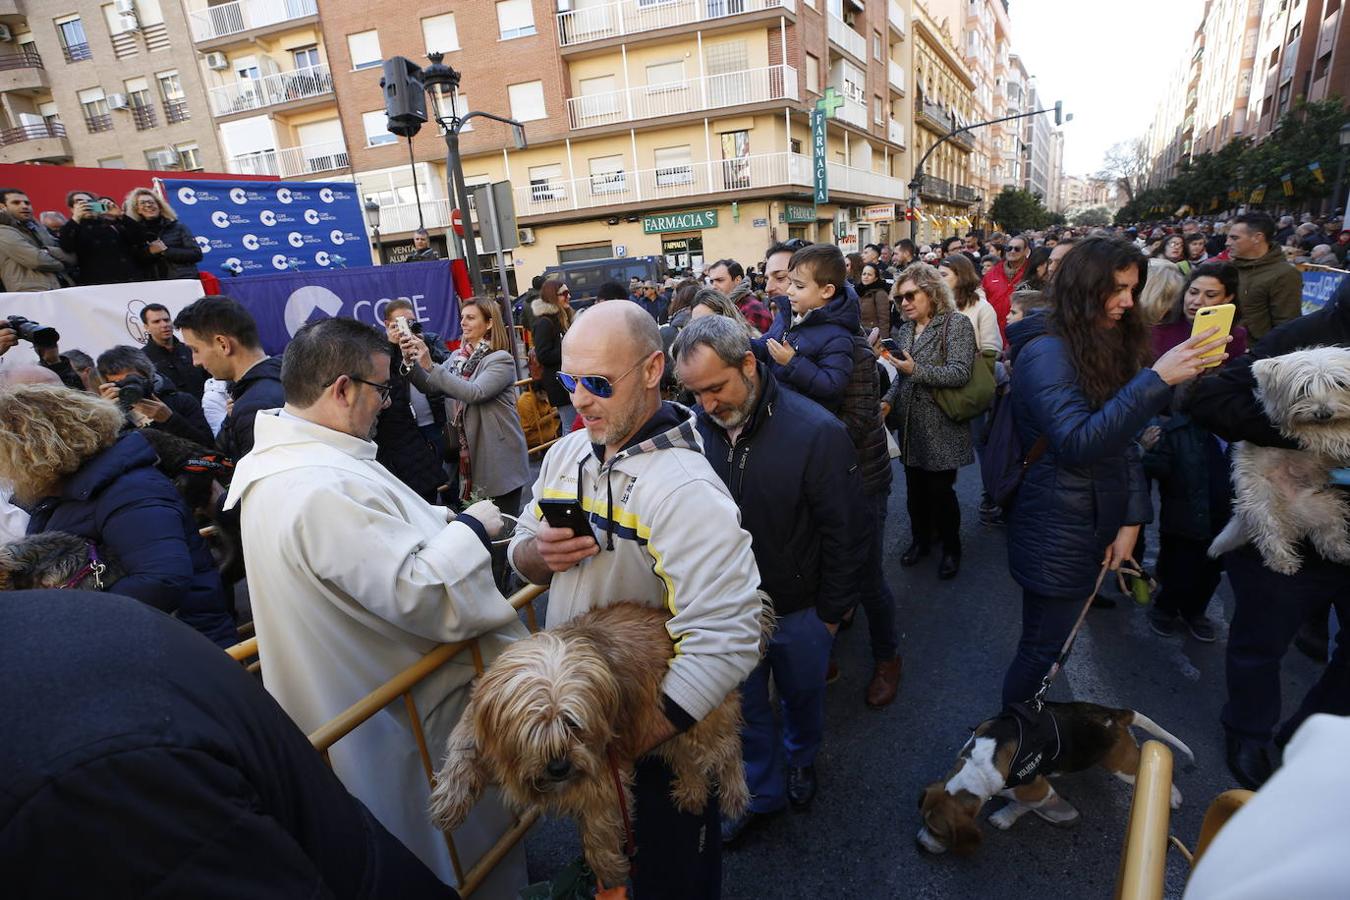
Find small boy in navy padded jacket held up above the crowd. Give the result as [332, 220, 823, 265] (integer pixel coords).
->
[756, 244, 861, 413]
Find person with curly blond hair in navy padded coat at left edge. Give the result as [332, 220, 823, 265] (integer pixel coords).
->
[0, 385, 239, 646]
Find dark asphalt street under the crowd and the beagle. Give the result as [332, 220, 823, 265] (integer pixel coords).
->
[527, 467, 1318, 900]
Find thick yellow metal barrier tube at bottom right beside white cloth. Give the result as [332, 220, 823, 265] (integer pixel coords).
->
[1115, 741, 1172, 900]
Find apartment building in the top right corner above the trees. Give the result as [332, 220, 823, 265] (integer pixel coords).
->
[1247, 0, 1350, 140]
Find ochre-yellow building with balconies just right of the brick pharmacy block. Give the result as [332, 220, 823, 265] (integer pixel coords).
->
[913, 5, 983, 242]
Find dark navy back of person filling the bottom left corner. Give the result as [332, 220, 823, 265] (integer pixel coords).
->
[0, 591, 456, 900]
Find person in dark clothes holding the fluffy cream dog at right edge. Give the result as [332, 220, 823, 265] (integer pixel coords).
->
[1189, 278, 1350, 789]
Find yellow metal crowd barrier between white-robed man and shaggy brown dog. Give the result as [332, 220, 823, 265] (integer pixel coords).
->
[225, 584, 548, 897]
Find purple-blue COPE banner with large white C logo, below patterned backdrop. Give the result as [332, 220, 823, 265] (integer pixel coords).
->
[220, 259, 459, 355]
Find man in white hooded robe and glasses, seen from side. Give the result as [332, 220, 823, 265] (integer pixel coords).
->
[225, 318, 525, 893]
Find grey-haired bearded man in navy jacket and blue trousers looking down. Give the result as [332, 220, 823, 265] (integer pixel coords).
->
[671, 316, 871, 843]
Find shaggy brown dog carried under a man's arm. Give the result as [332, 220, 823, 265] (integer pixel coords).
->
[431, 603, 749, 887]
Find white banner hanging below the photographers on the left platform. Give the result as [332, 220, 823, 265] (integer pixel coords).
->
[0, 278, 205, 363]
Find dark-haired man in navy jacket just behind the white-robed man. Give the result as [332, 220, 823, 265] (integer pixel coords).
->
[174, 296, 286, 460]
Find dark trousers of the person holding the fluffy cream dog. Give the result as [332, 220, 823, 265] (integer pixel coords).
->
[1222, 546, 1350, 742]
